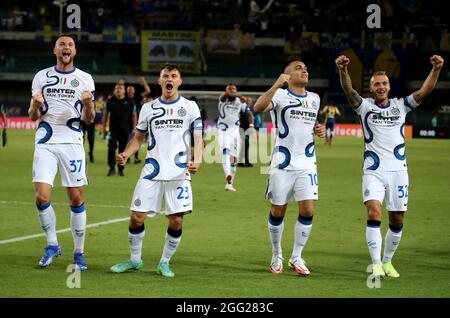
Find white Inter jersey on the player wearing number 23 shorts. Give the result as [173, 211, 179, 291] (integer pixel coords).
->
[136, 96, 202, 181]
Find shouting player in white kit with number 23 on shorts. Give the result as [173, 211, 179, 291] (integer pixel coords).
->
[111, 64, 203, 277]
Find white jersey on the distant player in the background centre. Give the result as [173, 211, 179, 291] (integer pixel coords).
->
[217, 97, 250, 133]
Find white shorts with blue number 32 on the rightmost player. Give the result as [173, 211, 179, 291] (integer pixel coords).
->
[362, 170, 409, 212]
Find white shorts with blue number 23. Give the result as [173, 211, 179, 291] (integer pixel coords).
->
[130, 178, 193, 217]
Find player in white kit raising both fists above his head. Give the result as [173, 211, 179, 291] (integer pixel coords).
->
[335, 55, 444, 278]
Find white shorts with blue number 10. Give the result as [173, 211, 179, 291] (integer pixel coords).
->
[266, 169, 319, 205]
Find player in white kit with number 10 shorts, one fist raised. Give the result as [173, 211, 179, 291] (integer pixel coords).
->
[254, 57, 325, 276]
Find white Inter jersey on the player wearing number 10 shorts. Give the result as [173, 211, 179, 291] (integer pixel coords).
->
[270, 88, 320, 170]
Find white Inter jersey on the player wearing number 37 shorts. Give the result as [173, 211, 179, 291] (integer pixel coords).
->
[31, 66, 95, 144]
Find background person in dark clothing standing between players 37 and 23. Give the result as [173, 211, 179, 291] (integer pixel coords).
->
[103, 84, 134, 177]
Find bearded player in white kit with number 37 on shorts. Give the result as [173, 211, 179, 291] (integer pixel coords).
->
[28, 35, 95, 271]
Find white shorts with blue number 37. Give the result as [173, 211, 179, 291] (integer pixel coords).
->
[33, 144, 88, 187]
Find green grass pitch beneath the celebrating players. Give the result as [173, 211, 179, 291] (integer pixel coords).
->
[0, 129, 450, 298]
